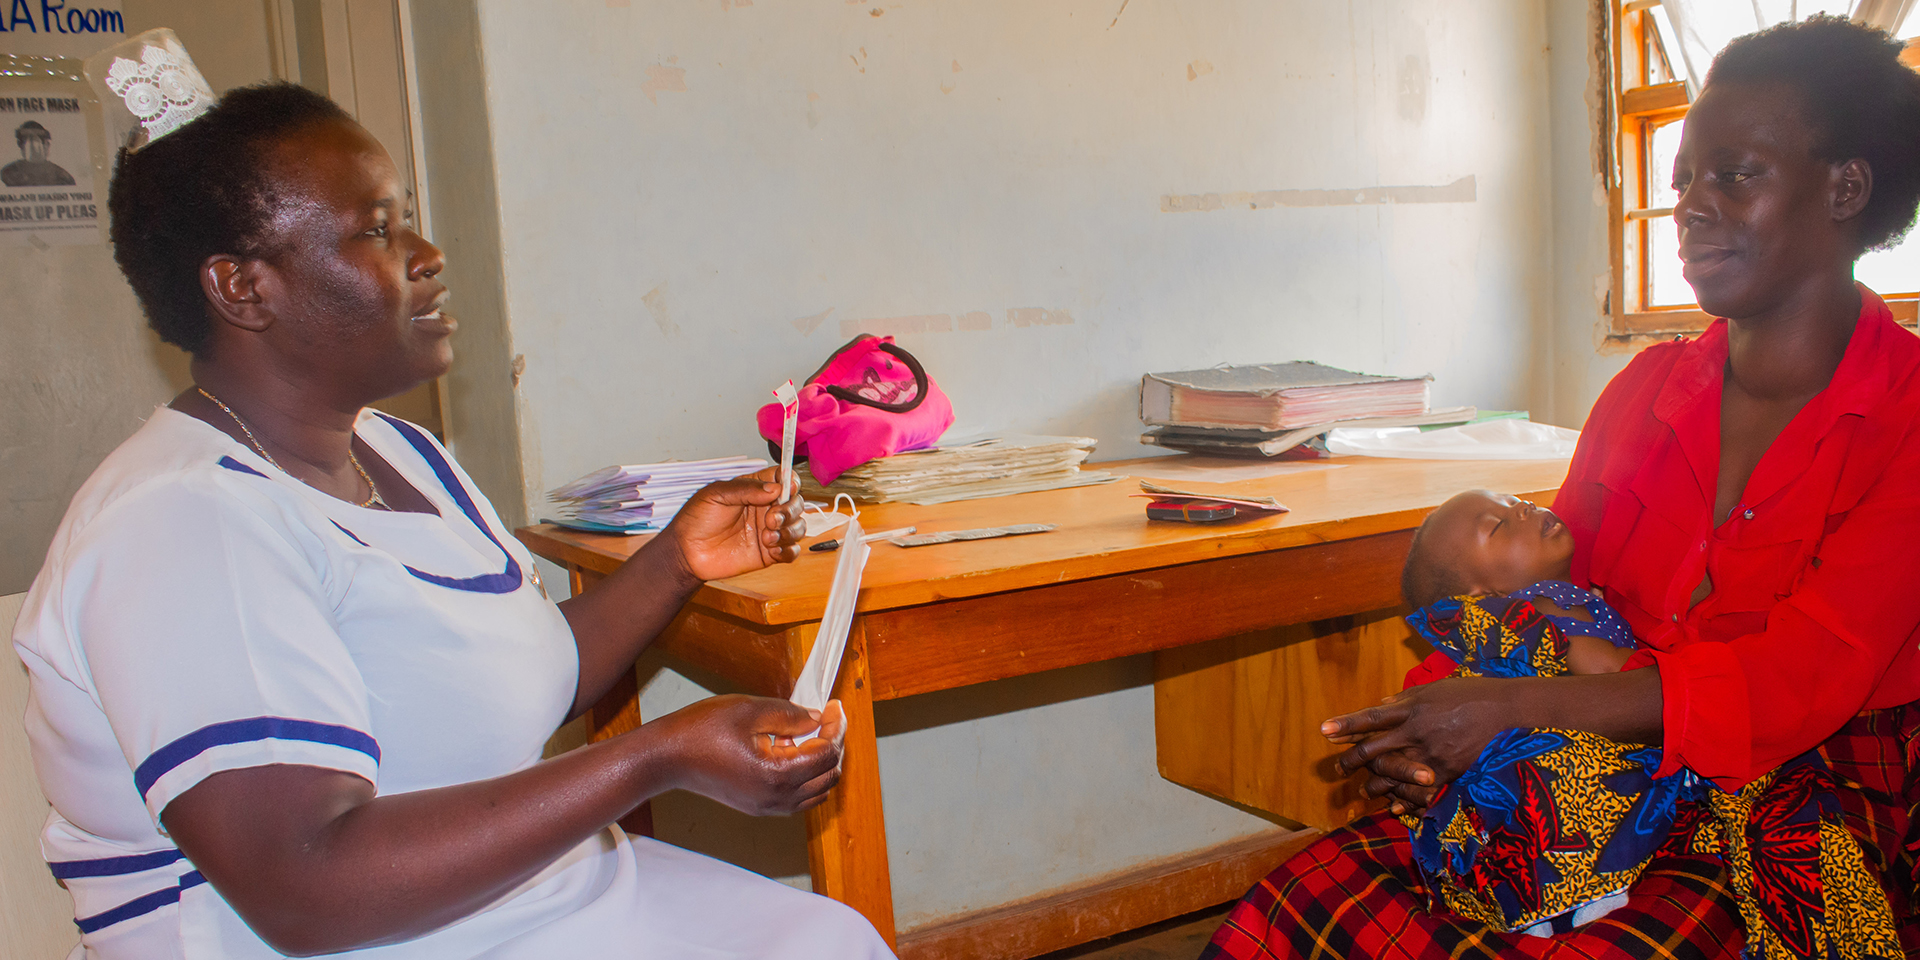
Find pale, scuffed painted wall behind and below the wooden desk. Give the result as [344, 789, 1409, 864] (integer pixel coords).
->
[460, 0, 1555, 927]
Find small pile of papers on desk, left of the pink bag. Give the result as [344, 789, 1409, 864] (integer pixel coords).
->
[547, 457, 766, 534]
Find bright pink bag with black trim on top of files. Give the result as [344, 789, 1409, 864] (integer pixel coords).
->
[756, 334, 954, 486]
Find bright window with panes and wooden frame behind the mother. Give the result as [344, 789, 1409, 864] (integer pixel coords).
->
[1609, 0, 1920, 336]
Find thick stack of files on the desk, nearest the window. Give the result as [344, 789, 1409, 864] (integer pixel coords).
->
[1140, 361, 1475, 457]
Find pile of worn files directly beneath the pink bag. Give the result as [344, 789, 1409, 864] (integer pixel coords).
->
[801, 436, 1119, 505]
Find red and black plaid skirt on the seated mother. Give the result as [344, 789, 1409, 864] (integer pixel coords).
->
[1200, 707, 1920, 960]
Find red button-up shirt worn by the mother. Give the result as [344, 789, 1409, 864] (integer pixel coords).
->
[1553, 286, 1920, 787]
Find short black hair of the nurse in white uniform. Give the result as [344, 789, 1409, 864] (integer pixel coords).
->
[108, 83, 351, 357]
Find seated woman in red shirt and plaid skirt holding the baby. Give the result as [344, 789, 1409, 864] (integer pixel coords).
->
[1204, 17, 1920, 958]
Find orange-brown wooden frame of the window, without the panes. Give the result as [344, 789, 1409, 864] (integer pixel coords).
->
[1603, 0, 1920, 340]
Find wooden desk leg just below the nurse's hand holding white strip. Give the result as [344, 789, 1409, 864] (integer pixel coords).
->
[806, 620, 897, 947]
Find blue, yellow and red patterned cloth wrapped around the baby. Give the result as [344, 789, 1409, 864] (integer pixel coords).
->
[1402, 582, 1901, 960]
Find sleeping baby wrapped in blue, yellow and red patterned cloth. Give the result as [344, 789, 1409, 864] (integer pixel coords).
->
[1400, 490, 1901, 958]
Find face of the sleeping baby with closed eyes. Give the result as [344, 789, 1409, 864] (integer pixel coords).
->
[1421, 490, 1572, 593]
